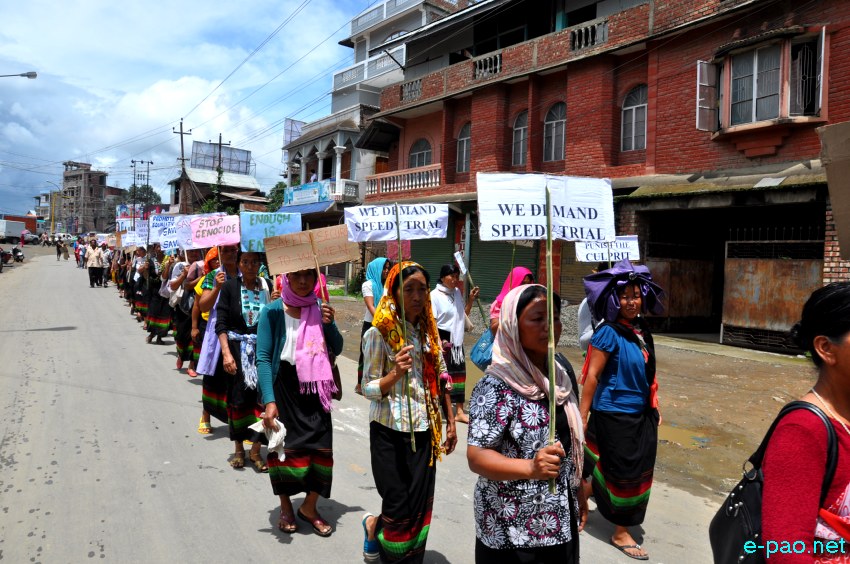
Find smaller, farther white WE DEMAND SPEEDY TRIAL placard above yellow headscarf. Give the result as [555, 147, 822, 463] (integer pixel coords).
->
[345, 204, 449, 243]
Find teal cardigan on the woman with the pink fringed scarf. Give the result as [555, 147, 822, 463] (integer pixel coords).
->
[257, 299, 342, 405]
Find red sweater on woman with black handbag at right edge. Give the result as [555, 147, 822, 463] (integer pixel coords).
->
[762, 410, 850, 564]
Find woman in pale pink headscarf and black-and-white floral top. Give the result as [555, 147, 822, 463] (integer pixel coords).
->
[466, 284, 587, 564]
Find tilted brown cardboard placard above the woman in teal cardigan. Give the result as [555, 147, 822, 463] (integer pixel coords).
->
[264, 225, 360, 274]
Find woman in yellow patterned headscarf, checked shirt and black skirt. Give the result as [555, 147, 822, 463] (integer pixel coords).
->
[361, 262, 457, 563]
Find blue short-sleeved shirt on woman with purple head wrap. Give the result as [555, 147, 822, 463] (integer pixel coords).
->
[590, 325, 649, 413]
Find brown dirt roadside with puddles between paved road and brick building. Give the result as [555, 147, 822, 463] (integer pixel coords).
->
[332, 298, 815, 503]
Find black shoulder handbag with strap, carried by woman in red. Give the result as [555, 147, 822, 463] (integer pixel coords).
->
[708, 401, 838, 564]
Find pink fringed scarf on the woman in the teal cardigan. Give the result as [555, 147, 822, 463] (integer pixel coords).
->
[280, 276, 337, 412]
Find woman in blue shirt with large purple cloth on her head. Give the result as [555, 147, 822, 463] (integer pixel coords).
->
[580, 260, 664, 560]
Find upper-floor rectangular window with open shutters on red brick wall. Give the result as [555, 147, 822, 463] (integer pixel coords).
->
[696, 30, 825, 131]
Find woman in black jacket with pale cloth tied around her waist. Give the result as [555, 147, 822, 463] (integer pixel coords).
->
[215, 253, 278, 472]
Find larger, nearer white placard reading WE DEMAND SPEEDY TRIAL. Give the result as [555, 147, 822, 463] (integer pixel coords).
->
[476, 172, 615, 241]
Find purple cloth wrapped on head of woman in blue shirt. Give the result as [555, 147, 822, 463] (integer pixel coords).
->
[584, 259, 664, 321]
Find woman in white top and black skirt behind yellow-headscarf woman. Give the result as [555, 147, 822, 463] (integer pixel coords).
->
[431, 264, 479, 423]
